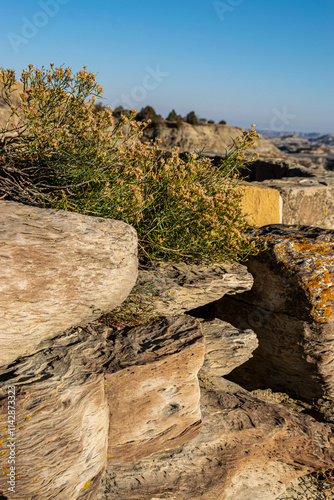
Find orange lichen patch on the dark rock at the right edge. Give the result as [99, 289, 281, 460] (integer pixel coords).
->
[260, 235, 334, 323]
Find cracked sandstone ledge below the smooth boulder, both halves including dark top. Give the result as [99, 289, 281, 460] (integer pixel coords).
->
[0, 316, 204, 500]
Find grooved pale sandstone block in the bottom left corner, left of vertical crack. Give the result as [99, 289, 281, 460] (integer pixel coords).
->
[0, 329, 109, 500]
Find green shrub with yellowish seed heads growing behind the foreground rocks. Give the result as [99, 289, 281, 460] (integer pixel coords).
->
[0, 65, 257, 261]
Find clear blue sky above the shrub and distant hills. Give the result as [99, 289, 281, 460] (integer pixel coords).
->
[0, 0, 334, 133]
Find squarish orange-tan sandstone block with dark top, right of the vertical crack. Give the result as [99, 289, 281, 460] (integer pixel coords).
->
[105, 316, 205, 464]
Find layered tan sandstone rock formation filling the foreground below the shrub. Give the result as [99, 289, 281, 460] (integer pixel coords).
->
[0, 203, 334, 500]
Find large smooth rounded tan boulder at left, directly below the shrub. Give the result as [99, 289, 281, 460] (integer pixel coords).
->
[0, 201, 137, 365]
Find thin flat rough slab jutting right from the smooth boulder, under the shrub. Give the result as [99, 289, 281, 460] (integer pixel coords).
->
[136, 262, 253, 315]
